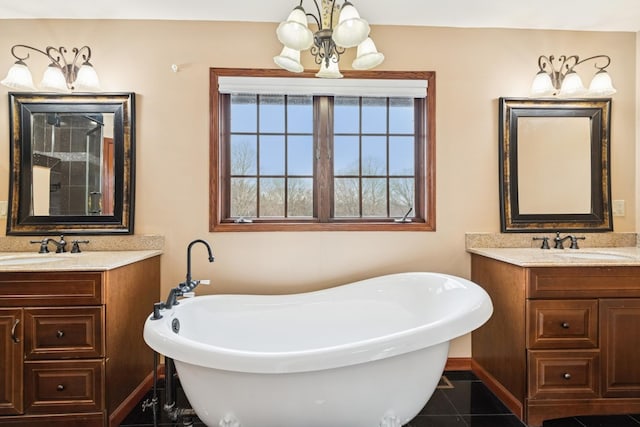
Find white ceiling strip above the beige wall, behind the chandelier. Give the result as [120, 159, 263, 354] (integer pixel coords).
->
[0, 0, 640, 32]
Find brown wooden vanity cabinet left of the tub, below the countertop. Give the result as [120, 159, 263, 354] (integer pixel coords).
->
[0, 256, 160, 427]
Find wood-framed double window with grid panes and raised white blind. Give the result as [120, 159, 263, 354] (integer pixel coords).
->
[210, 69, 435, 231]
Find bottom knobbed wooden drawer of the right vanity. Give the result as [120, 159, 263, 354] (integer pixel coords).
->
[528, 350, 600, 399]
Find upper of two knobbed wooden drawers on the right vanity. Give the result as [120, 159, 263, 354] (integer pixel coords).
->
[527, 299, 598, 349]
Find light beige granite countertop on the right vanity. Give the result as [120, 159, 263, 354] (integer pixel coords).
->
[467, 246, 640, 267]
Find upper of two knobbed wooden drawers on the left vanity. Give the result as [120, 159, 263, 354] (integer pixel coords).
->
[24, 306, 104, 360]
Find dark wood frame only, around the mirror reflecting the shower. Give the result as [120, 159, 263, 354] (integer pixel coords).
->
[7, 93, 135, 235]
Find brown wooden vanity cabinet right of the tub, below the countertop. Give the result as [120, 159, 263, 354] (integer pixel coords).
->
[471, 254, 640, 426]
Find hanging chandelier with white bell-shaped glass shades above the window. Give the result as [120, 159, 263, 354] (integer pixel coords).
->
[273, 0, 384, 78]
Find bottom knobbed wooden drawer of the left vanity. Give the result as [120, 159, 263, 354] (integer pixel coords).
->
[24, 360, 104, 414]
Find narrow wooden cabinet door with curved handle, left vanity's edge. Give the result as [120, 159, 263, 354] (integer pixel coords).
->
[0, 308, 23, 415]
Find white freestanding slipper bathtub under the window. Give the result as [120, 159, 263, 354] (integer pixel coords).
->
[144, 272, 493, 427]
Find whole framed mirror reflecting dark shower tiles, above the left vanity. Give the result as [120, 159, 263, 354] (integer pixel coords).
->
[7, 93, 135, 235]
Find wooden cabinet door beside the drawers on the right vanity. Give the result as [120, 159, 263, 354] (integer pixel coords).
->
[600, 298, 640, 397]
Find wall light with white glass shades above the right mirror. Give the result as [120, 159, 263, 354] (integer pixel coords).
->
[531, 55, 616, 97]
